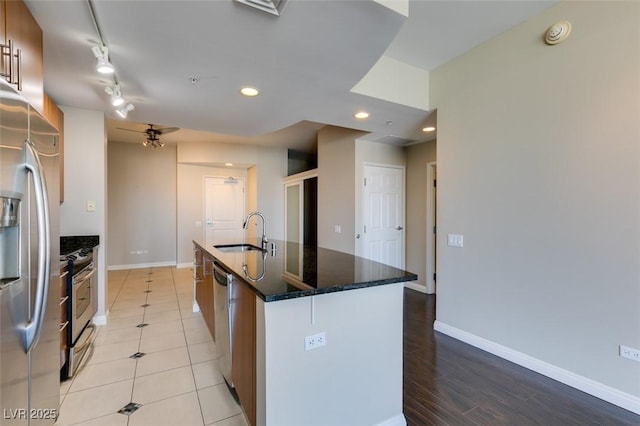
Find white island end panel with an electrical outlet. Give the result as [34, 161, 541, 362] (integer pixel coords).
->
[256, 283, 406, 426]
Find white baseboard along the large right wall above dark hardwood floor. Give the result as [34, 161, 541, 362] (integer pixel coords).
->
[433, 321, 640, 414]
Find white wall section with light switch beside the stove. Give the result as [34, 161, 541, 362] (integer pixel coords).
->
[60, 106, 108, 322]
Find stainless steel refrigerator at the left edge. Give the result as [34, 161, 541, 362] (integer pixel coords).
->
[0, 81, 60, 426]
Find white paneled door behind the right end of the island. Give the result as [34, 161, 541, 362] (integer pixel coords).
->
[363, 165, 405, 269]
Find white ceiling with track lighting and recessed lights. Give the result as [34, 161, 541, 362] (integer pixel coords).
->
[26, 0, 555, 152]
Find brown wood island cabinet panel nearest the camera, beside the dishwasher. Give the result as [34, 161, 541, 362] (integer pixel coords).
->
[231, 281, 256, 425]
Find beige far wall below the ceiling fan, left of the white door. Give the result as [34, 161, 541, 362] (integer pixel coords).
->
[107, 142, 176, 269]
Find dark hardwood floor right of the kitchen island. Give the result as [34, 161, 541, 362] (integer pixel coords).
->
[404, 289, 640, 426]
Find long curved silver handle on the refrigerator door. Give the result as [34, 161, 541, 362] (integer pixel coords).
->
[20, 140, 51, 353]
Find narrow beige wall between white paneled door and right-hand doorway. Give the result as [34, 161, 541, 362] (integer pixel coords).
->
[405, 141, 436, 290]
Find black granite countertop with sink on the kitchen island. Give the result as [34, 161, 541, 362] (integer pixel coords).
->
[194, 240, 418, 302]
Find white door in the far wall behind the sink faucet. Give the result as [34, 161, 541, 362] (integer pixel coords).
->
[204, 177, 244, 247]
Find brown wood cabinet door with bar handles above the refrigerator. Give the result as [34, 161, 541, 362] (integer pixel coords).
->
[3, 0, 44, 113]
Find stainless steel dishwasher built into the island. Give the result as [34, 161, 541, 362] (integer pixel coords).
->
[213, 261, 234, 393]
